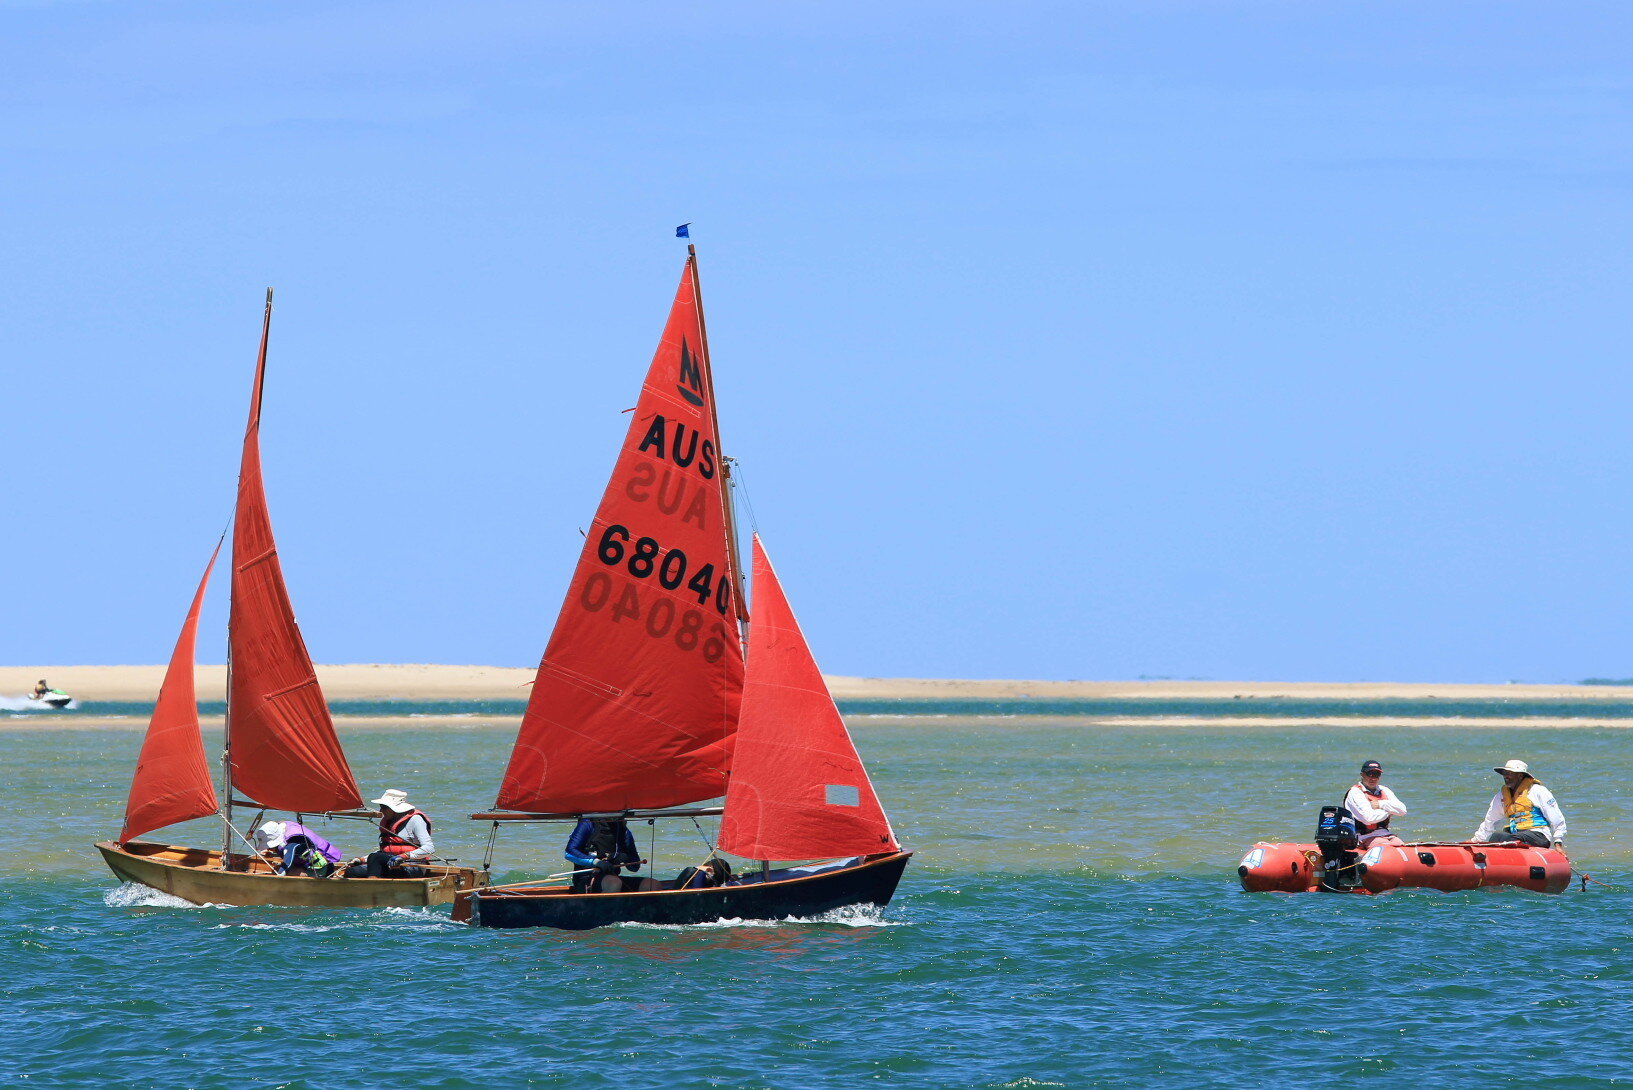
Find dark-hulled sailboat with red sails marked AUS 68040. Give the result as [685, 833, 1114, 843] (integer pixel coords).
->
[454, 252, 911, 930]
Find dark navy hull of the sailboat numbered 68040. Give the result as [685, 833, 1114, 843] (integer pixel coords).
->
[454, 850, 913, 930]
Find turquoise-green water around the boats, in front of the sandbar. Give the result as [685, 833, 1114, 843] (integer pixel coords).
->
[9, 716, 1633, 1087]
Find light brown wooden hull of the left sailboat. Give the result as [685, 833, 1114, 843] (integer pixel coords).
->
[96, 840, 485, 909]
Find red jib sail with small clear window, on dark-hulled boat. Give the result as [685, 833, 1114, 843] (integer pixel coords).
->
[720, 534, 897, 860]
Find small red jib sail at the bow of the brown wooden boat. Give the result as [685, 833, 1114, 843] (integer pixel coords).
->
[119, 544, 220, 843]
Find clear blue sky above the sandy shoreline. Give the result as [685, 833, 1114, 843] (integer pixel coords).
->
[0, 0, 1633, 681]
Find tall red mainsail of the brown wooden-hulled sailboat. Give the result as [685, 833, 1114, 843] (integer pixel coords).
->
[227, 293, 363, 814]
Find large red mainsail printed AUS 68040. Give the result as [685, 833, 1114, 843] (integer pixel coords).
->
[498, 258, 743, 812]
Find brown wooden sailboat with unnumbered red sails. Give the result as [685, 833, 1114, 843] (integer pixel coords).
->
[96, 289, 485, 909]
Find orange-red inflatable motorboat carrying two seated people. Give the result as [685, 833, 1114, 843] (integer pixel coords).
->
[1236, 840, 1571, 894]
